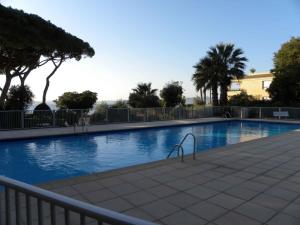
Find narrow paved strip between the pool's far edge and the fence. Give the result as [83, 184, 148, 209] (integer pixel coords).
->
[0, 117, 225, 141]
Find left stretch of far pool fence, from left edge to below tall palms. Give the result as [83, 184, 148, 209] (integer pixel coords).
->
[0, 107, 222, 130]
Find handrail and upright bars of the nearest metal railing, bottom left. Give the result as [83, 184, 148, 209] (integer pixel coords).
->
[0, 176, 158, 225]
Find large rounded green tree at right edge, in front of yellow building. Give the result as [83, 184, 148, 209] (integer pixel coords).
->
[268, 38, 300, 106]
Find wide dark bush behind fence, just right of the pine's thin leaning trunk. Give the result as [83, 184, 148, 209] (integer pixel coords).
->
[54, 91, 97, 109]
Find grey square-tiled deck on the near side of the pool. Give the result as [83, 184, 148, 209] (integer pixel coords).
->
[37, 128, 300, 225]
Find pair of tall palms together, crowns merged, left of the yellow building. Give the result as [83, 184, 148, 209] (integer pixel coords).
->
[192, 43, 247, 105]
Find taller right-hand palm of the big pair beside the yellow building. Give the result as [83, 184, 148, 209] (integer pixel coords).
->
[207, 43, 247, 105]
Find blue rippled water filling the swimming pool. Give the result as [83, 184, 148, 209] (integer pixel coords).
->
[0, 121, 300, 184]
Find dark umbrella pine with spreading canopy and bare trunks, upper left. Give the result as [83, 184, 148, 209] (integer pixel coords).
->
[0, 4, 95, 107]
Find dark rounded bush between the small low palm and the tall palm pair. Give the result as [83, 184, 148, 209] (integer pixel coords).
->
[160, 81, 185, 107]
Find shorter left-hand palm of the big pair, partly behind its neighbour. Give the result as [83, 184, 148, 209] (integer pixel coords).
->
[192, 57, 218, 105]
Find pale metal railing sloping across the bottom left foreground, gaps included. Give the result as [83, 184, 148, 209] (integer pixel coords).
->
[0, 176, 158, 225]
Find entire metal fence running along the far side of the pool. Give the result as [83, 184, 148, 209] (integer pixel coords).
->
[0, 106, 300, 130]
